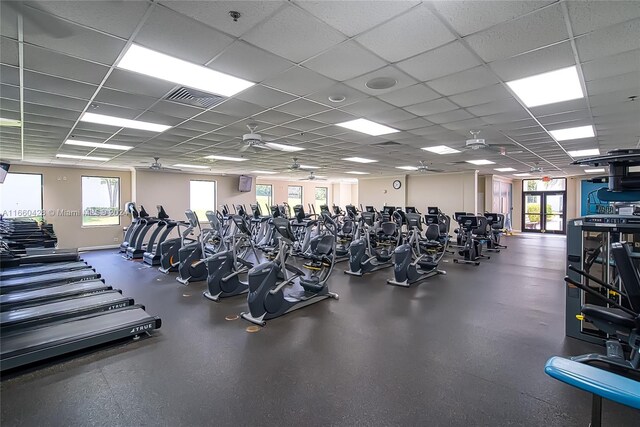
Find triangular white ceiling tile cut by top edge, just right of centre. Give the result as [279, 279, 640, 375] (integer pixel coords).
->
[300, 1, 419, 37]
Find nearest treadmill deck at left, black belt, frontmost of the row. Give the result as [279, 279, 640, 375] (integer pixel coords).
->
[0, 306, 161, 371]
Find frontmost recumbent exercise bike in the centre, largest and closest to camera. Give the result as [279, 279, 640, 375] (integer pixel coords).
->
[240, 218, 338, 326]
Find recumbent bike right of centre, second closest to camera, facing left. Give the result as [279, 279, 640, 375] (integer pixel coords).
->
[387, 213, 447, 288]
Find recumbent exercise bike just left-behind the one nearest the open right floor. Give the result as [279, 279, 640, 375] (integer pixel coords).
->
[344, 209, 400, 276]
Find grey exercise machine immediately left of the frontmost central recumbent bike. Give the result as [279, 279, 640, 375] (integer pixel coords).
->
[203, 215, 259, 302]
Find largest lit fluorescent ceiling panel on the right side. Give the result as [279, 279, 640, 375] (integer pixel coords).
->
[507, 66, 584, 107]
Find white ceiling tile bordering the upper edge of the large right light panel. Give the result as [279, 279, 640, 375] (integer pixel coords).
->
[489, 42, 576, 81]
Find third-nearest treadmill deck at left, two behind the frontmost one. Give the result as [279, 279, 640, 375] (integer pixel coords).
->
[0, 280, 111, 311]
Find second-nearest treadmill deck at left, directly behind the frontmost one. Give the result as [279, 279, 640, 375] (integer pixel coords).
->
[0, 291, 133, 332]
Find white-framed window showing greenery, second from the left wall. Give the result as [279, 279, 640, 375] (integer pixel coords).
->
[82, 176, 120, 227]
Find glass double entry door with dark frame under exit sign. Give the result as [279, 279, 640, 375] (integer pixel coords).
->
[522, 191, 566, 234]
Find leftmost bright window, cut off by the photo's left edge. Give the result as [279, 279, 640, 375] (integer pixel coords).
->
[0, 173, 44, 218]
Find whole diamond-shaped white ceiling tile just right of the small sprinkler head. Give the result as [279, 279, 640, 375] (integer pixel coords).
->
[243, 6, 345, 62]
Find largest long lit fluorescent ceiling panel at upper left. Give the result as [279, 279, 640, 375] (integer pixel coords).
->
[118, 44, 255, 96]
